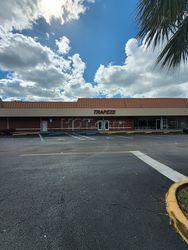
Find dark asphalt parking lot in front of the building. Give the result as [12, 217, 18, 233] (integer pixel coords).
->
[0, 134, 188, 250]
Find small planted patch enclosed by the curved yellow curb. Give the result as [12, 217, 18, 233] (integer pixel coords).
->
[177, 185, 188, 218]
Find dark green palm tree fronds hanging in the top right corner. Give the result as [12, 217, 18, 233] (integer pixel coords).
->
[138, 0, 188, 69]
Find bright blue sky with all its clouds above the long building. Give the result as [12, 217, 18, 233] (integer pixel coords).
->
[0, 0, 188, 101]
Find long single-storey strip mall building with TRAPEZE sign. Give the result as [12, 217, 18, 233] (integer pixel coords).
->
[0, 98, 188, 132]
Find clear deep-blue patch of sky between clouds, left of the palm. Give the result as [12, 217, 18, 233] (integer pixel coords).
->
[22, 0, 137, 81]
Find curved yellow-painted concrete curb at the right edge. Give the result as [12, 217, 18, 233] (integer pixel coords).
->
[166, 179, 188, 244]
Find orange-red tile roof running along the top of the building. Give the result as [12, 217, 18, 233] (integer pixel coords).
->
[0, 98, 188, 109]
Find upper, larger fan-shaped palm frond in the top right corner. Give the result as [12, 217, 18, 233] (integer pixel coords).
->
[137, 0, 188, 47]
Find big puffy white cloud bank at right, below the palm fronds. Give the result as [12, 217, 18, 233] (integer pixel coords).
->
[95, 39, 188, 97]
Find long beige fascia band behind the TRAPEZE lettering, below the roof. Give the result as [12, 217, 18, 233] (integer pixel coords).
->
[0, 108, 188, 117]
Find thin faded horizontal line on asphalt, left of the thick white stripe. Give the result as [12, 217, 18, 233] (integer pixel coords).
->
[20, 151, 131, 157]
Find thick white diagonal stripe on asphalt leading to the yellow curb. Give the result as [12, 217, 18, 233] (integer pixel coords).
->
[130, 151, 188, 182]
